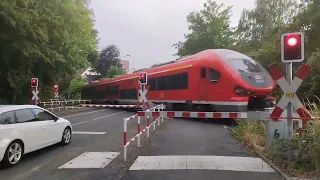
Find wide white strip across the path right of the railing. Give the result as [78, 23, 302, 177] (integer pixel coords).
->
[129, 156, 275, 172]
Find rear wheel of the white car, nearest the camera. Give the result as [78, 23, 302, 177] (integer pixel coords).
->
[3, 140, 23, 167]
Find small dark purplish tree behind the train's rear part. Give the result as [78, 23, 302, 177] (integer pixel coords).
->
[95, 44, 122, 77]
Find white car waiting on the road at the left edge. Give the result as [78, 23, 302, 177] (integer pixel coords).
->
[0, 105, 72, 167]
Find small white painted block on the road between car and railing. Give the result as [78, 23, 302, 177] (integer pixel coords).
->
[58, 152, 120, 169]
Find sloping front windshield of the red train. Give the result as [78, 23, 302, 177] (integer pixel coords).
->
[215, 49, 266, 73]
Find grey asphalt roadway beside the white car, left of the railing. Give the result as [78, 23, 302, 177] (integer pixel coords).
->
[0, 109, 135, 180]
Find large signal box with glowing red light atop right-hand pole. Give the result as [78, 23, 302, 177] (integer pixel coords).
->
[281, 32, 304, 63]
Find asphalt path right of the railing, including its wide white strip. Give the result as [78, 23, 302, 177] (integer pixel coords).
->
[119, 119, 282, 180]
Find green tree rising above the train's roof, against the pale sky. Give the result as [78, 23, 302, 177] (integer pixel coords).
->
[173, 0, 233, 56]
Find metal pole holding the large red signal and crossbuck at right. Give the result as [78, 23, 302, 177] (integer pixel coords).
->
[286, 63, 293, 161]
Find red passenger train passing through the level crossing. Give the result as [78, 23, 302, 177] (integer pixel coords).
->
[82, 49, 275, 112]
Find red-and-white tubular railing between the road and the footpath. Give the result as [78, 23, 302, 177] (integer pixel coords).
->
[123, 104, 165, 161]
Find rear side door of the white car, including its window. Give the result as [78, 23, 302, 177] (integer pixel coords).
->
[15, 109, 46, 151]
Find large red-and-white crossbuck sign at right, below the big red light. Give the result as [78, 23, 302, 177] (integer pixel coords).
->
[270, 64, 311, 120]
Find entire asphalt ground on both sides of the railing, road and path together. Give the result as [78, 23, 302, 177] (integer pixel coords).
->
[0, 109, 282, 180]
